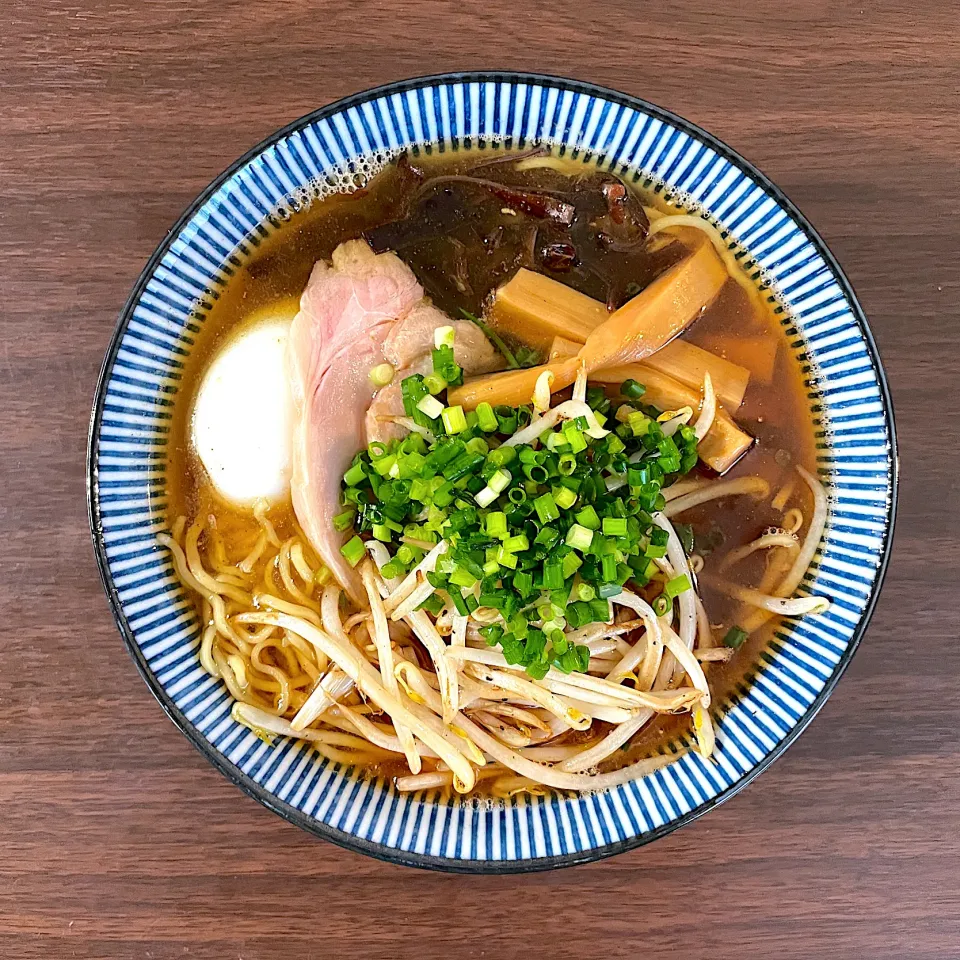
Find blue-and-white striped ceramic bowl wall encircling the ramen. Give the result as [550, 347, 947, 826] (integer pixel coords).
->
[88, 74, 897, 872]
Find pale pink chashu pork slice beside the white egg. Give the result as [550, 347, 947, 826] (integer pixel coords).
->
[287, 240, 499, 604]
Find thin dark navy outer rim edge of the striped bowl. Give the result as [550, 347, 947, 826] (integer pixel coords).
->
[85, 70, 899, 875]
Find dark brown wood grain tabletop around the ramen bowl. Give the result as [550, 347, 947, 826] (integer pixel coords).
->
[0, 0, 960, 960]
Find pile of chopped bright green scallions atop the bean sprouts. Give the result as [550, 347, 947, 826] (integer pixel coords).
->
[334, 328, 697, 678]
